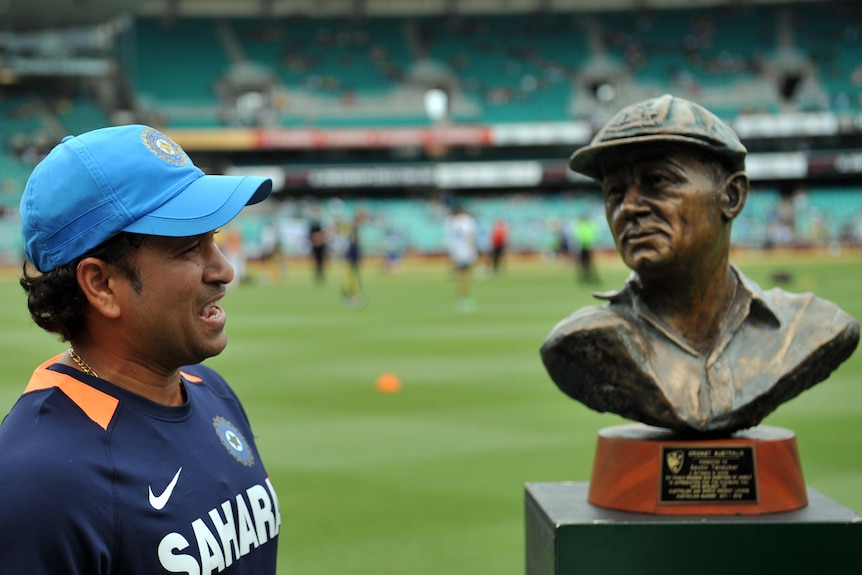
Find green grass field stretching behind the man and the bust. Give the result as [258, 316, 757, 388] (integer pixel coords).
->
[0, 253, 862, 575]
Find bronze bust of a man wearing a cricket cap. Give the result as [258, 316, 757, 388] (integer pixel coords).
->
[541, 95, 859, 434]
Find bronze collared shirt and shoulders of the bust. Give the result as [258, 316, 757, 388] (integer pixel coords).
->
[542, 266, 859, 432]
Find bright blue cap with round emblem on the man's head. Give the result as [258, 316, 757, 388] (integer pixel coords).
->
[20, 124, 272, 272]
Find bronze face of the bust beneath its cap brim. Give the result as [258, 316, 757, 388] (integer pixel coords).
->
[600, 146, 729, 277]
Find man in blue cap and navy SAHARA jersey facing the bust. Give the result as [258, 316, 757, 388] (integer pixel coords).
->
[0, 125, 281, 575]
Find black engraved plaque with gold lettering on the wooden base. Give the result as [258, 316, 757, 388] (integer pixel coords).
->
[659, 445, 758, 504]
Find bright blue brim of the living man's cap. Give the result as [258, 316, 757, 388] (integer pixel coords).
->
[123, 175, 272, 237]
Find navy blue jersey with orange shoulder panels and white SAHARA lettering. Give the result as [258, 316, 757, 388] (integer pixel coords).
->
[0, 356, 281, 575]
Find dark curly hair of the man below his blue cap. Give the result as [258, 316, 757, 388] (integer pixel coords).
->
[20, 232, 144, 341]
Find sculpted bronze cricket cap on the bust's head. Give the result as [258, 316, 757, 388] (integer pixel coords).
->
[569, 94, 748, 180]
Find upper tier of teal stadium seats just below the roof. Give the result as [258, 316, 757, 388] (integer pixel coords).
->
[121, 4, 862, 126]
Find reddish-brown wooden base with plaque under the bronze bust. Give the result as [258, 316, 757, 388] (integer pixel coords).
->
[588, 424, 808, 515]
